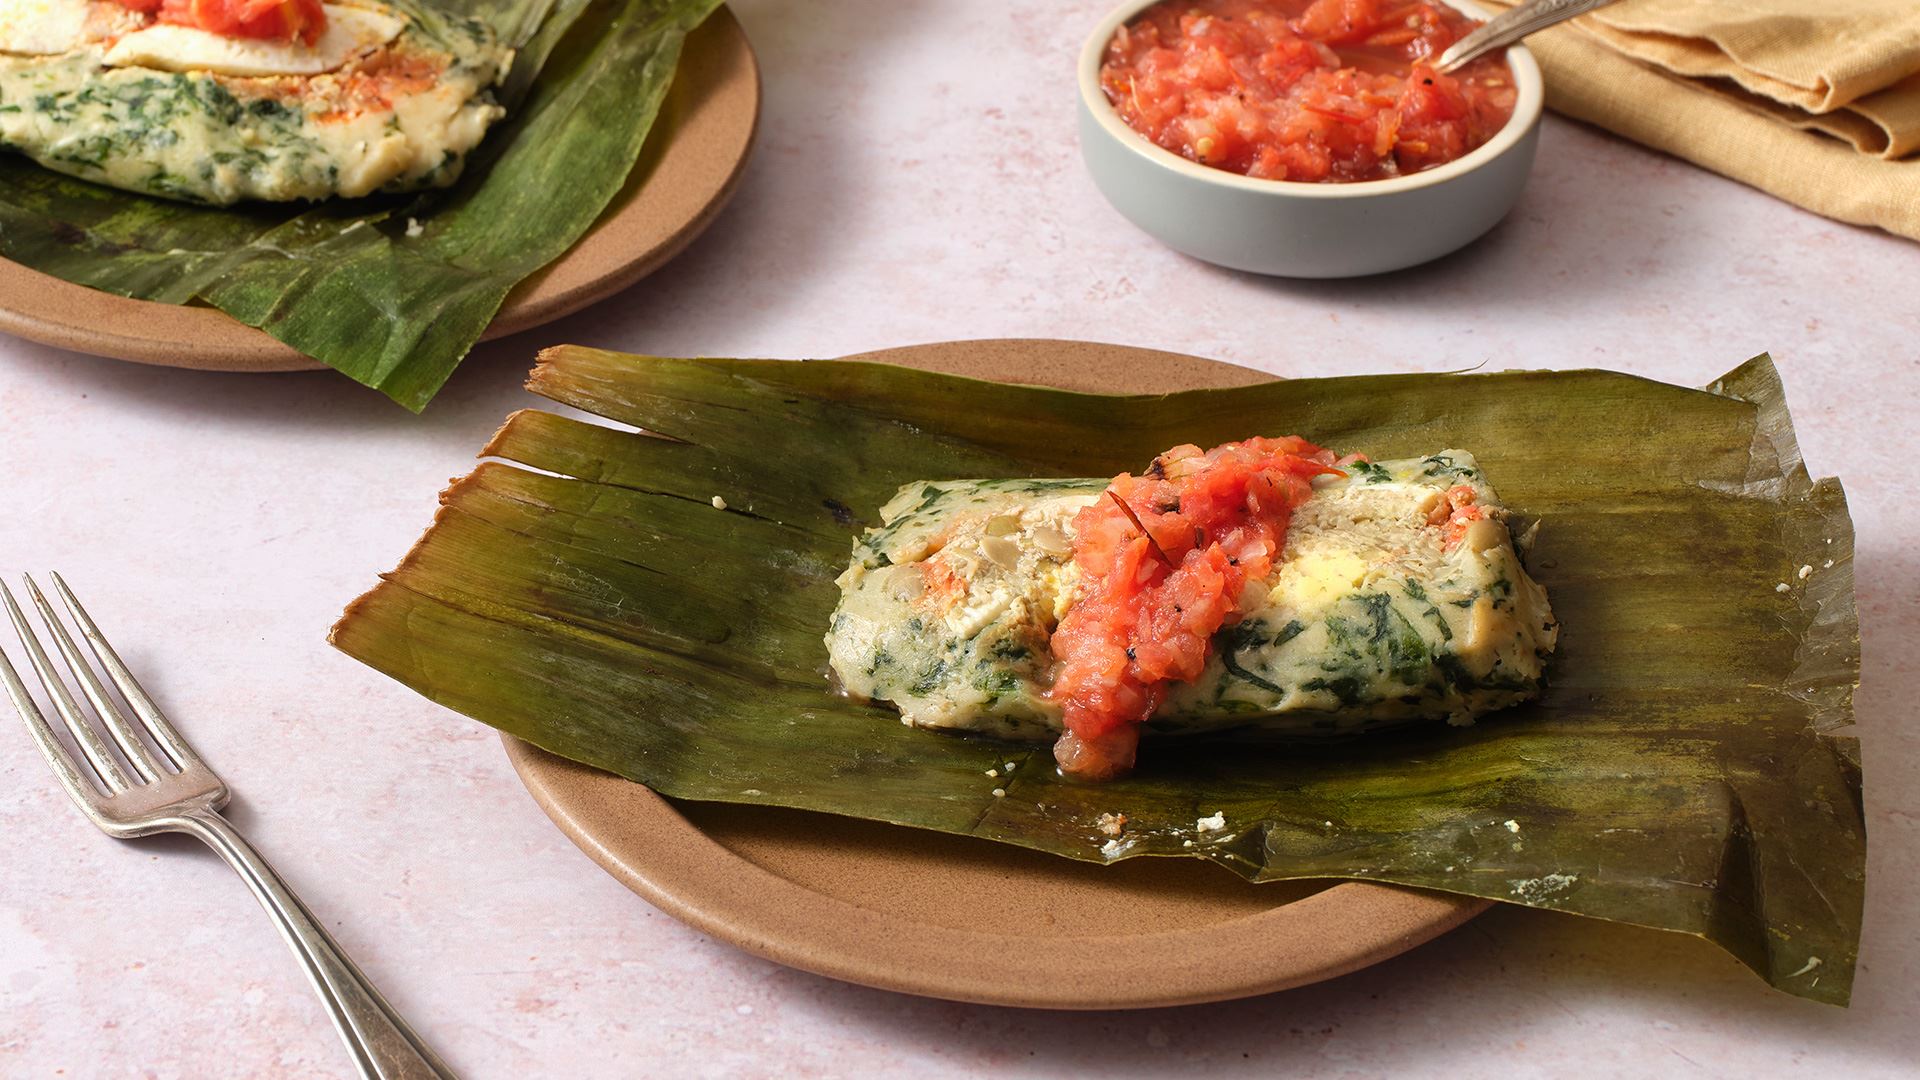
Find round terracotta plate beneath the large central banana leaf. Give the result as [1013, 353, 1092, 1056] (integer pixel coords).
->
[505, 340, 1488, 1009]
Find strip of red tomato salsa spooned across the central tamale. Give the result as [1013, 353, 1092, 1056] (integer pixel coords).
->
[1052, 436, 1351, 780]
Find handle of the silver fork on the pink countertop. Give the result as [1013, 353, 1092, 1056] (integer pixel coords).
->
[175, 809, 453, 1080]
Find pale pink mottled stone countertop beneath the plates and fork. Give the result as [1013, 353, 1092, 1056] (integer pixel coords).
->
[0, 0, 1920, 1078]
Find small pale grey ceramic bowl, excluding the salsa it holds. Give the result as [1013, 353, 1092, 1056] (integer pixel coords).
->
[1079, 0, 1542, 277]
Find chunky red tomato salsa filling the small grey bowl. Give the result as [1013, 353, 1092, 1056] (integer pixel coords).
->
[1100, 0, 1517, 183]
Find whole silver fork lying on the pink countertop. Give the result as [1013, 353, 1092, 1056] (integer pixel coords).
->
[0, 575, 453, 1078]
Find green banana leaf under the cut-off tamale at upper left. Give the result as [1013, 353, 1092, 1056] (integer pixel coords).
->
[0, 0, 720, 411]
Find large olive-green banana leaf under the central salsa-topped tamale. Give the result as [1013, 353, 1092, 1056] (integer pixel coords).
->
[332, 346, 1866, 1003]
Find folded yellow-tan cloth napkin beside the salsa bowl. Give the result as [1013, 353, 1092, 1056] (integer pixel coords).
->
[1490, 0, 1920, 240]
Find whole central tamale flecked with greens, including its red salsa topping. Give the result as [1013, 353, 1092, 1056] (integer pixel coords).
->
[828, 438, 1557, 778]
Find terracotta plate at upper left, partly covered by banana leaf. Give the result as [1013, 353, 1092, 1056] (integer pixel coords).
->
[0, 8, 760, 371]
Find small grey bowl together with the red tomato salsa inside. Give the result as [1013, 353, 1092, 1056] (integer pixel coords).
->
[1079, 0, 1544, 277]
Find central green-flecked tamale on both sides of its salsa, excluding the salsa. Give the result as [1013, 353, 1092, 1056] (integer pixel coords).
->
[826, 450, 1557, 740]
